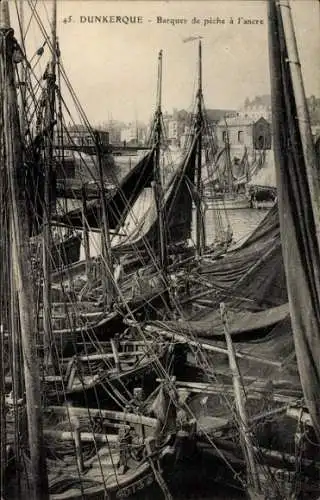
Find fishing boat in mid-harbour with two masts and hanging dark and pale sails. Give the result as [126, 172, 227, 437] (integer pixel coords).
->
[37, 44, 232, 348]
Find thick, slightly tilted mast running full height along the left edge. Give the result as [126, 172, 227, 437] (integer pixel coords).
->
[0, 0, 49, 500]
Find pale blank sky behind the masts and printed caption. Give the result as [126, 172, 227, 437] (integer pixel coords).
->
[10, 0, 320, 124]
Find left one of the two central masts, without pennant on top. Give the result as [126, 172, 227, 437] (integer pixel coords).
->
[154, 50, 167, 273]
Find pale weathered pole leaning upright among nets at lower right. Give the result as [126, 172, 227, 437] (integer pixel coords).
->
[220, 303, 260, 494]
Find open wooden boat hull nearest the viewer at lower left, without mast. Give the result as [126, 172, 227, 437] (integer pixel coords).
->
[45, 407, 188, 500]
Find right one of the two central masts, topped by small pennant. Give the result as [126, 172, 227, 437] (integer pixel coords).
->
[196, 40, 205, 256]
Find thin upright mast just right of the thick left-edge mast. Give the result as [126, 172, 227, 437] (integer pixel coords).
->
[42, 0, 57, 366]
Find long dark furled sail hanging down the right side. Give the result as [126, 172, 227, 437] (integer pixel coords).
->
[269, 0, 320, 439]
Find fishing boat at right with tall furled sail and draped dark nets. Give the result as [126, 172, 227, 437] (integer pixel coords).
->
[139, 1, 320, 499]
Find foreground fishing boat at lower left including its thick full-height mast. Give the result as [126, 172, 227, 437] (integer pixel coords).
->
[0, 0, 198, 500]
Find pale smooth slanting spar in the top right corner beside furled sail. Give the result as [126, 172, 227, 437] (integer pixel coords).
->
[278, 0, 320, 248]
